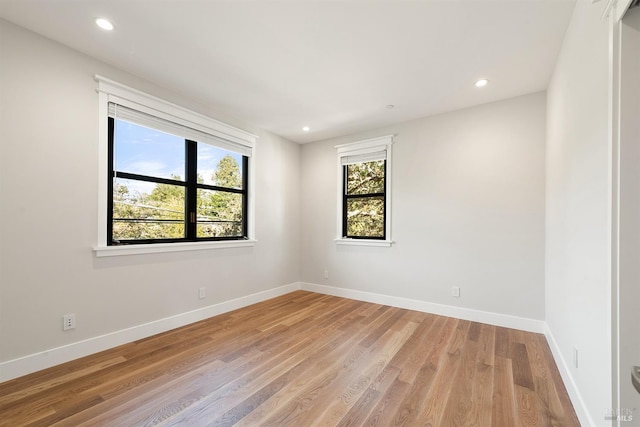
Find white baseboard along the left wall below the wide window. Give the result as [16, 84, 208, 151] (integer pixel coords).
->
[0, 283, 300, 382]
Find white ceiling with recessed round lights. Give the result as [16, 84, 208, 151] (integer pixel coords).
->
[0, 0, 574, 143]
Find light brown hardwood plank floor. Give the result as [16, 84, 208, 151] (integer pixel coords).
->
[0, 291, 579, 427]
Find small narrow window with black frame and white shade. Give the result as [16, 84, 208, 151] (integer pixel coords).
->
[336, 136, 393, 246]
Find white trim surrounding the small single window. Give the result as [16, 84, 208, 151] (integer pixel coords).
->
[335, 135, 394, 247]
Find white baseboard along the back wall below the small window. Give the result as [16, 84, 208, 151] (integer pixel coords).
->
[300, 283, 546, 334]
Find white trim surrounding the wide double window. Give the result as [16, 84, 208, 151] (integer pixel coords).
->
[93, 75, 258, 257]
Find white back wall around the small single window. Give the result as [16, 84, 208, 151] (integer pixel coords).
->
[301, 93, 545, 319]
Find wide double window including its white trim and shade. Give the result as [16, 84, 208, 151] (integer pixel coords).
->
[96, 76, 255, 256]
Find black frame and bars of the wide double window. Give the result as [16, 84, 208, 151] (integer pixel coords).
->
[107, 117, 249, 246]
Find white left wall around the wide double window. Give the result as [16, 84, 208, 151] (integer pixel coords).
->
[0, 20, 300, 376]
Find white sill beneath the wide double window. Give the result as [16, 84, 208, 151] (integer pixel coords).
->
[93, 240, 256, 257]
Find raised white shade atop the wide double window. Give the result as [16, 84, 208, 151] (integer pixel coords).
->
[109, 102, 252, 157]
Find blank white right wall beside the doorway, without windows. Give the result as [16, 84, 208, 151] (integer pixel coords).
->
[545, 0, 612, 425]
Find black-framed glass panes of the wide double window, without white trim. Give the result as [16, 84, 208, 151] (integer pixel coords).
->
[108, 113, 248, 245]
